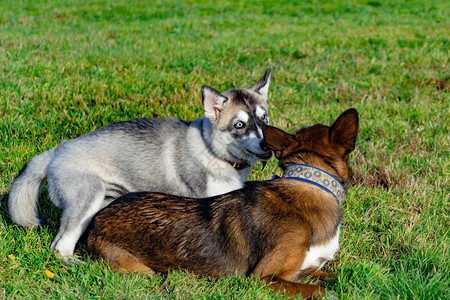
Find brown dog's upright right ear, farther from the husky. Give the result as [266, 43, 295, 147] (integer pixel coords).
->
[330, 108, 359, 155]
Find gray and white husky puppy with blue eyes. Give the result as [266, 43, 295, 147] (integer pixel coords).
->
[9, 69, 271, 261]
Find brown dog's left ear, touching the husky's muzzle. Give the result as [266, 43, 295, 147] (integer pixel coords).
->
[262, 124, 297, 158]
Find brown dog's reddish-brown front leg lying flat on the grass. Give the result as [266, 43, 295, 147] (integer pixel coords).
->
[261, 275, 326, 299]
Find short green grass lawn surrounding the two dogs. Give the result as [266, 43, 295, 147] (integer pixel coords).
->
[0, 0, 450, 299]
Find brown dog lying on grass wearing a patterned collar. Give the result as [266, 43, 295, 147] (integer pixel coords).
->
[88, 109, 358, 297]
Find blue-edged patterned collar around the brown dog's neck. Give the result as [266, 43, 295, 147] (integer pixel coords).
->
[274, 164, 345, 205]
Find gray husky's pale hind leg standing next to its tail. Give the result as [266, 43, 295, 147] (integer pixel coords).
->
[49, 174, 107, 263]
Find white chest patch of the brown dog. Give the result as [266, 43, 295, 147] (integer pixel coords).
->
[299, 226, 340, 273]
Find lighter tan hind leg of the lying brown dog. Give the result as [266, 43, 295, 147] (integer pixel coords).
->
[101, 246, 155, 274]
